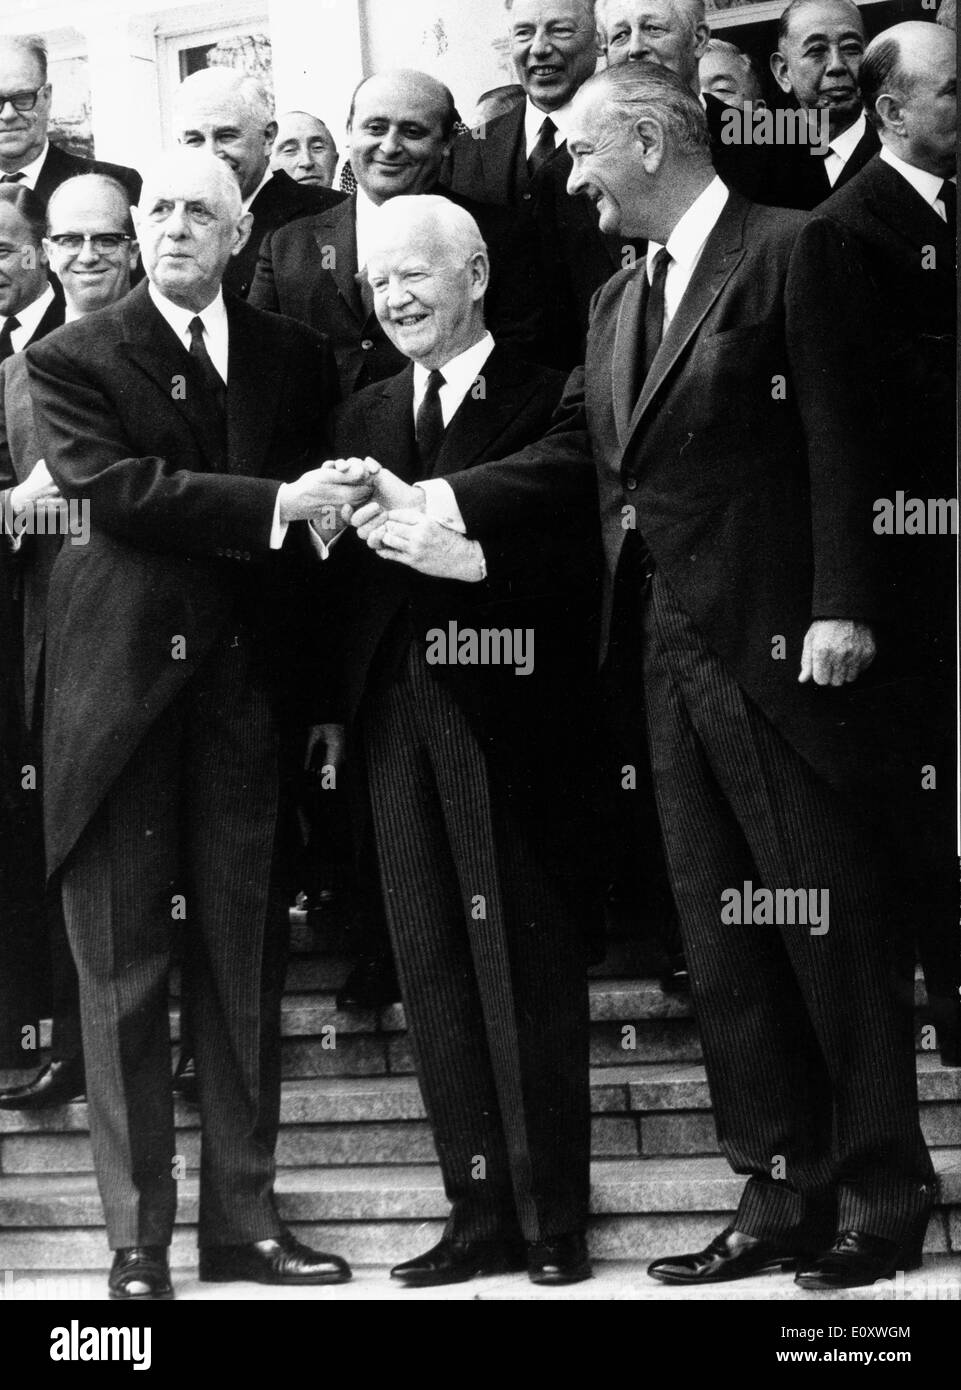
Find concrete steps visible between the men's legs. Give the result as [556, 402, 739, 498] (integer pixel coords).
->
[0, 927, 961, 1270]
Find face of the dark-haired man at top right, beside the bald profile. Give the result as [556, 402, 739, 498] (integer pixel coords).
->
[770, 0, 865, 135]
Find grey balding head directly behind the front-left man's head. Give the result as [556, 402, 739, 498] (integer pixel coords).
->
[174, 68, 277, 197]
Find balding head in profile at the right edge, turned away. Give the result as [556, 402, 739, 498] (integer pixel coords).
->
[861, 21, 958, 178]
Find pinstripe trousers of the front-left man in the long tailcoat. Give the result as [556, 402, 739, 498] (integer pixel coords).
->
[63, 632, 286, 1250]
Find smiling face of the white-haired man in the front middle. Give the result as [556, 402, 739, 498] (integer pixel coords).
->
[367, 222, 488, 370]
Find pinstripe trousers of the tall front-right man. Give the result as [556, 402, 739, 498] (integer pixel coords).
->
[643, 573, 933, 1240]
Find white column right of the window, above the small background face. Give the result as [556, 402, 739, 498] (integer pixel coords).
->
[268, 0, 366, 153]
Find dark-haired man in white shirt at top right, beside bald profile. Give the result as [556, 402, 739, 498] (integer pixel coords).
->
[764, 0, 879, 209]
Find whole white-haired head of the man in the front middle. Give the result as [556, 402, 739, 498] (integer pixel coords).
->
[367, 193, 490, 370]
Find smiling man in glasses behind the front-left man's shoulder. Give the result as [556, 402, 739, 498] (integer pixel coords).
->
[0, 175, 138, 1111]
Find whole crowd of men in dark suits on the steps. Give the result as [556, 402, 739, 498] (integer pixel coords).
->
[0, 0, 961, 1298]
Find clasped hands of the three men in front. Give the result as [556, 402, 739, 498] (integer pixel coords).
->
[280, 459, 487, 584]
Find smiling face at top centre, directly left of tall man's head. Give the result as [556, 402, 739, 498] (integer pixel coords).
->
[510, 0, 597, 111]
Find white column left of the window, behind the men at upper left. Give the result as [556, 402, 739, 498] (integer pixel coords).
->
[81, 14, 160, 168]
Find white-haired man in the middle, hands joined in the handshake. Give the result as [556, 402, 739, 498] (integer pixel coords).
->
[319, 196, 598, 1287]
